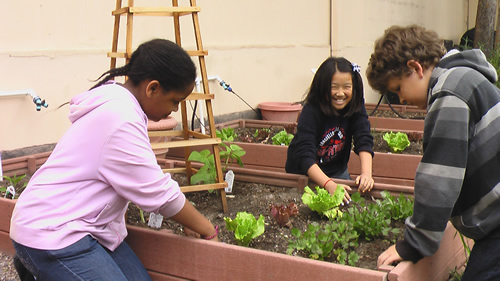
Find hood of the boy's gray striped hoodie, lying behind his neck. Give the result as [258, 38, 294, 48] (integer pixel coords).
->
[430, 49, 498, 88]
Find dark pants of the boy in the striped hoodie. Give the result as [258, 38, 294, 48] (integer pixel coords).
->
[462, 233, 500, 281]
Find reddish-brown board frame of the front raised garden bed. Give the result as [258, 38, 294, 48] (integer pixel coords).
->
[0, 153, 465, 281]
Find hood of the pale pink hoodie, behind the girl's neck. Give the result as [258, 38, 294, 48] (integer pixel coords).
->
[68, 83, 147, 123]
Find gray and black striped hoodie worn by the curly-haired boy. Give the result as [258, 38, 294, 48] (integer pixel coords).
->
[396, 50, 500, 262]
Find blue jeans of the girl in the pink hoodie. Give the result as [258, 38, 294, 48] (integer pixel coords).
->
[12, 235, 151, 281]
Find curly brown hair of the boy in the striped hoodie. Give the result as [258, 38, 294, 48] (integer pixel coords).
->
[366, 25, 446, 94]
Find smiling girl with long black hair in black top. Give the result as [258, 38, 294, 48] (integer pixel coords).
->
[285, 57, 373, 202]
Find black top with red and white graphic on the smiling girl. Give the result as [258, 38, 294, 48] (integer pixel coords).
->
[285, 104, 373, 176]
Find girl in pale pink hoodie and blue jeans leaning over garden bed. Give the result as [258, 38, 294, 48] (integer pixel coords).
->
[10, 39, 218, 280]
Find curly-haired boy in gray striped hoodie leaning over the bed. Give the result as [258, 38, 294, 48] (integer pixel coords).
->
[366, 25, 500, 280]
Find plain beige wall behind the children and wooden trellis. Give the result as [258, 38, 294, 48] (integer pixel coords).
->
[0, 0, 477, 150]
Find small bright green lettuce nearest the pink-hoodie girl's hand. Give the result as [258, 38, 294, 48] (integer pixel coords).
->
[224, 212, 265, 247]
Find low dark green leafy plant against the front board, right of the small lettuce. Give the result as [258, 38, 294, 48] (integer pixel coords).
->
[287, 221, 359, 266]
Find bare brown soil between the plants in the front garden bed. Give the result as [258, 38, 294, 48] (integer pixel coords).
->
[127, 174, 403, 269]
